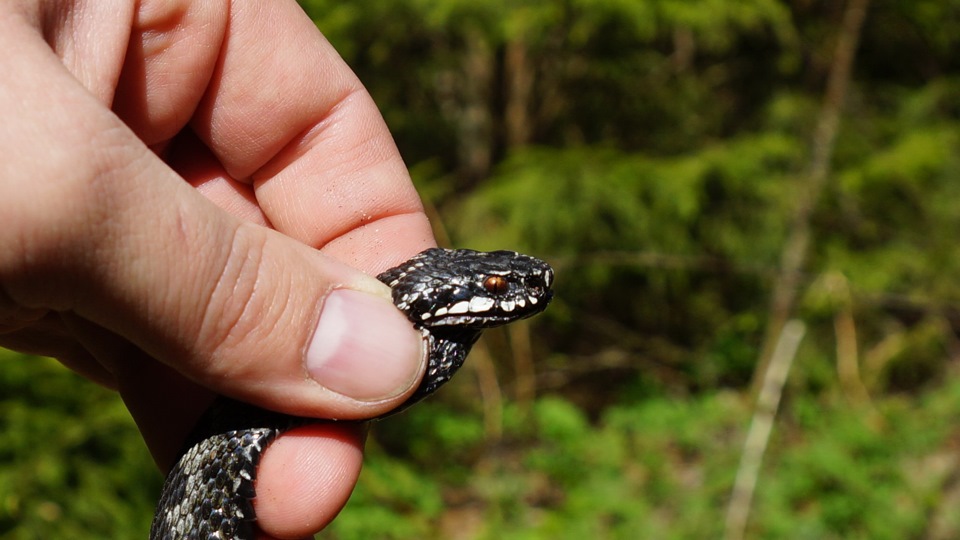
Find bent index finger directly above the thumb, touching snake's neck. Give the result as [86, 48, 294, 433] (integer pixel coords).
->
[192, 1, 433, 272]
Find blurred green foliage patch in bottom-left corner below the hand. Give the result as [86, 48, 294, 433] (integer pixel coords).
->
[0, 349, 162, 539]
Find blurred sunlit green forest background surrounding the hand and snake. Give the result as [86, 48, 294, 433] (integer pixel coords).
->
[0, 0, 960, 539]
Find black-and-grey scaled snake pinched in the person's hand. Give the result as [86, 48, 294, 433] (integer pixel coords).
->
[150, 248, 554, 540]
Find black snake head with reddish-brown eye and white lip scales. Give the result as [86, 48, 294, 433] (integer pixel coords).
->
[377, 248, 553, 329]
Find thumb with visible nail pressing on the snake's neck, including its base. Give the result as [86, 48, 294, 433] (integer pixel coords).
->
[0, 13, 422, 418]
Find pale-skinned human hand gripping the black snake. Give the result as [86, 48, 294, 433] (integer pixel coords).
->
[0, 0, 434, 538]
